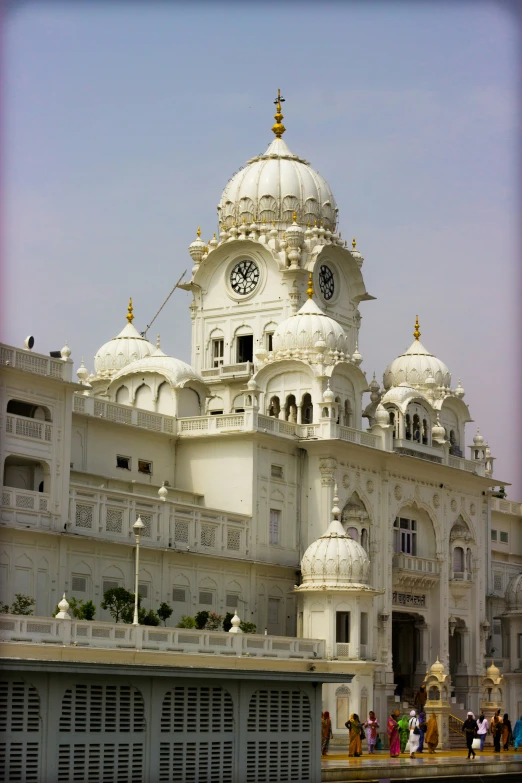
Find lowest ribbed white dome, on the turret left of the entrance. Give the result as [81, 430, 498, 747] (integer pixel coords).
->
[301, 519, 370, 589]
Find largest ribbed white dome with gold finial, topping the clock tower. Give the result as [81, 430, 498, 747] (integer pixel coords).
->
[218, 94, 338, 231]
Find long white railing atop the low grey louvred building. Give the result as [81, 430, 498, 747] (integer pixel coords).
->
[0, 614, 325, 659]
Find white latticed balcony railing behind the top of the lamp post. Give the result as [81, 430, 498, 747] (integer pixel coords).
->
[68, 482, 250, 558]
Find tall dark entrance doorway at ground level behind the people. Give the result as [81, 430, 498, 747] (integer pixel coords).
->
[392, 612, 420, 702]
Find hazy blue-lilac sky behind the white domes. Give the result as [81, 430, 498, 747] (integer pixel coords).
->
[2, 0, 522, 500]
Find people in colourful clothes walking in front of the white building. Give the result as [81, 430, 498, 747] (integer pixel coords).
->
[321, 710, 522, 759]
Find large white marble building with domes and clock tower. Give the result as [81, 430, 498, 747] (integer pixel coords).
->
[0, 92, 522, 731]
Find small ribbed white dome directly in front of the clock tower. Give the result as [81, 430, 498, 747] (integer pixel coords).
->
[272, 299, 348, 355]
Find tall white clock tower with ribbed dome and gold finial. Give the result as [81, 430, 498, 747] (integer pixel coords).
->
[181, 95, 373, 413]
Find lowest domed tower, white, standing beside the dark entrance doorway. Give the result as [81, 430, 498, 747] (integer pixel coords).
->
[294, 487, 382, 733]
